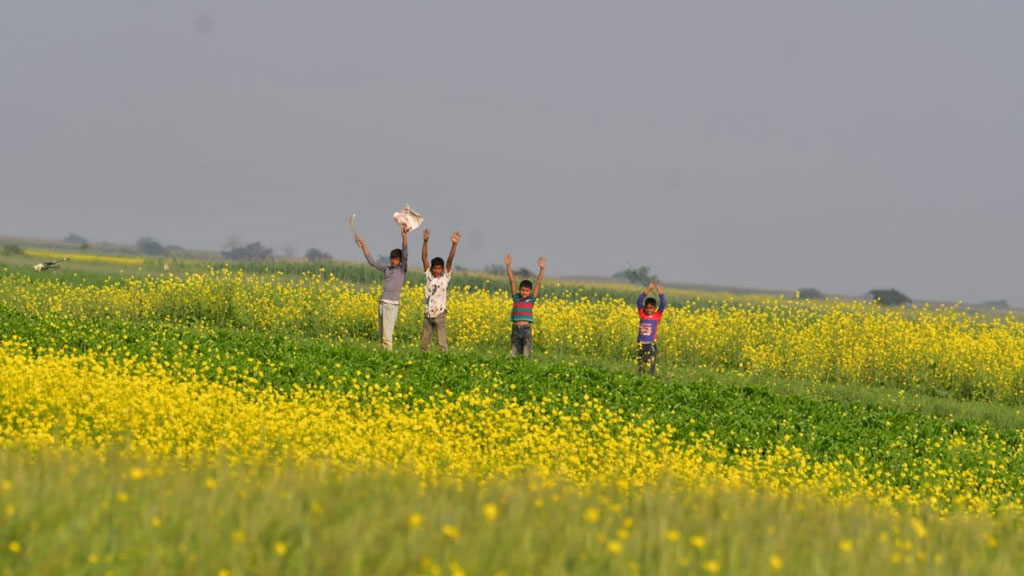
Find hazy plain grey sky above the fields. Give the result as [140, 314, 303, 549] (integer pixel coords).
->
[0, 0, 1024, 306]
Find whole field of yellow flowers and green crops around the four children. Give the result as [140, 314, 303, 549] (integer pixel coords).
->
[0, 262, 1024, 574]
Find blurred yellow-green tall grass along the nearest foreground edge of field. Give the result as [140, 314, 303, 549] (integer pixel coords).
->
[0, 450, 1024, 575]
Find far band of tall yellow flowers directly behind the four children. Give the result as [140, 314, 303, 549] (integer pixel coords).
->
[0, 270, 1024, 404]
